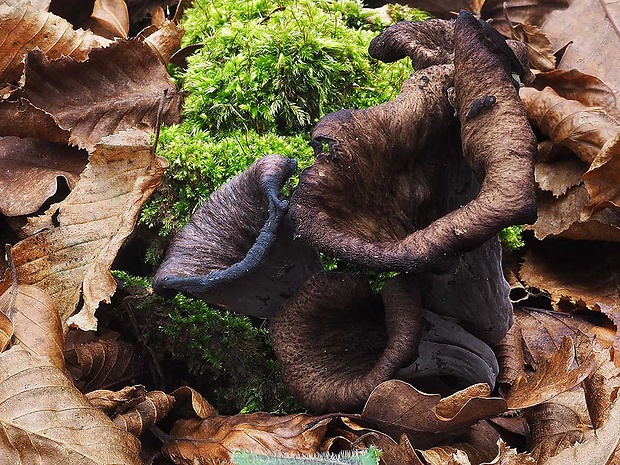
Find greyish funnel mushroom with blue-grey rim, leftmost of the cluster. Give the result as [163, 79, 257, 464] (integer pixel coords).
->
[153, 155, 320, 317]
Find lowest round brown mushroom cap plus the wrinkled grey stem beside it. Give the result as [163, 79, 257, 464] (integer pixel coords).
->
[270, 272, 499, 412]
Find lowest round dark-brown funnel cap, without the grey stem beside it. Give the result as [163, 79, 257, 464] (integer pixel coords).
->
[271, 272, 421, 412]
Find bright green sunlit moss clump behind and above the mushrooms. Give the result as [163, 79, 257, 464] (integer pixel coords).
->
[141, 0, 426, 264]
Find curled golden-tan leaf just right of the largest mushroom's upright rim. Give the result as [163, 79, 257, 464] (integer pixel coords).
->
[519, 87, 620, 163]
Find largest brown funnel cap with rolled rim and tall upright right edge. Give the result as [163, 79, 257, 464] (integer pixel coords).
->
[291, 15, 536, 272]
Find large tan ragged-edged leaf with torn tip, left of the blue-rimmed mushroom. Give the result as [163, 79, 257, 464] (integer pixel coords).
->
[2, 130, 167, 330]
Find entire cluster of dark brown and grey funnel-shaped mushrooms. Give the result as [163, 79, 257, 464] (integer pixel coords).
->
[154, 12, 536, 412]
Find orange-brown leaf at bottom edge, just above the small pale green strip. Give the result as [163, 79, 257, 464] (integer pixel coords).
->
[162, 412, 329, 463]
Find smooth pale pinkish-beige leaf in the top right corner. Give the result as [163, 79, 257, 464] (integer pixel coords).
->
[542, 0, 620, 114]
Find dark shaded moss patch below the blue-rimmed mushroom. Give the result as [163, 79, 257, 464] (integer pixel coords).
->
[113, 271, 302, 414]
